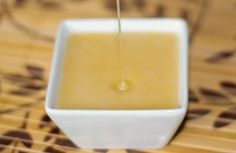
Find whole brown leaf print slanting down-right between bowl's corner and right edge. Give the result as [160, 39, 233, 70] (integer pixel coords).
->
[199, 88, 232, 104]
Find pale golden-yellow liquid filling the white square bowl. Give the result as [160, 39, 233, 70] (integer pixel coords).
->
[56, 33, 179, 110]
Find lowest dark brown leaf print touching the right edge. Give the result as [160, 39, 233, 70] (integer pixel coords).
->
[213, 107, 236, 128]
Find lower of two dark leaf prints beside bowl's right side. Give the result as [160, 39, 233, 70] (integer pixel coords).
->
[186, 108, 211, 120]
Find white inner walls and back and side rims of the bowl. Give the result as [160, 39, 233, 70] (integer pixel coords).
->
[46, 19, 188, 109]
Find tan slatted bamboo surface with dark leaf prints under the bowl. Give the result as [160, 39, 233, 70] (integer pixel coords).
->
[0, 0, 236, 153]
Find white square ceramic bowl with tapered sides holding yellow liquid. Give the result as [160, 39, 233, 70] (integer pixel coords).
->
[46, 19, 188, 149]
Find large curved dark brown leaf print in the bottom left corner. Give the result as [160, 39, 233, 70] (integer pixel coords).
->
[3, 130, 33, 148]
